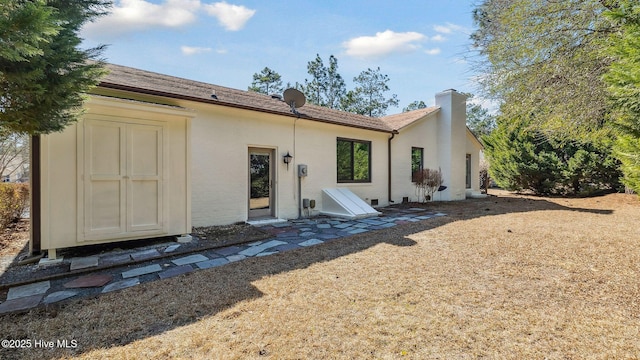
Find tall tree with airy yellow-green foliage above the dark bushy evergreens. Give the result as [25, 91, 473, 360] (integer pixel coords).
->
[471, 0, 616, 140]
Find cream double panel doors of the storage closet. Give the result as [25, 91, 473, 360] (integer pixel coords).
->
[83, 120, 166, 240]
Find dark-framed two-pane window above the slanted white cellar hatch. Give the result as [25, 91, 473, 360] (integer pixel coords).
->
[337, 138, 371, 183]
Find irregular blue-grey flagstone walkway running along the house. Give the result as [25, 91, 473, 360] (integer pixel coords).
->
[0, 208, 445, 314]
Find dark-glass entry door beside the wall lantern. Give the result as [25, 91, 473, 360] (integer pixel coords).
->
[249, 148, 274, 218]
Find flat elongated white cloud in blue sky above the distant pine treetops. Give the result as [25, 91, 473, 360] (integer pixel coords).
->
[342, 30, 426, 58]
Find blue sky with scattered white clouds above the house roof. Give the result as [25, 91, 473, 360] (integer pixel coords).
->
[80, 0, 477, 114]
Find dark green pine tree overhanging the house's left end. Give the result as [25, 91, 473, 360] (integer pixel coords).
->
[0, 0, 111, 135]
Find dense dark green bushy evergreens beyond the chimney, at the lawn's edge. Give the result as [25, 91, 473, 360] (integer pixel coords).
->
[483, 118, 620, 195]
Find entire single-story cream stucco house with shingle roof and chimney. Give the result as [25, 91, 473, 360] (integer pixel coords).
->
[32, 65, 481, 258]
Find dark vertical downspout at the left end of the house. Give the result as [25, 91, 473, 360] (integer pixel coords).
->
[29, 135, 42, 255]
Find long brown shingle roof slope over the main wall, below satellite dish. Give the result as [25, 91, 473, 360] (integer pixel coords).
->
[99, 64, 394, 132]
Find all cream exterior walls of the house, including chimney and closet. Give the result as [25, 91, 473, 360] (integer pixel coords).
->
[41, 84, 481, 249]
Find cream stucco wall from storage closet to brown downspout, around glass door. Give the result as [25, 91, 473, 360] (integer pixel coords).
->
[185, 100, 389, 226]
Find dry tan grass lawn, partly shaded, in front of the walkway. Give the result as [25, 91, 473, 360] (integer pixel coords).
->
[0, 192, 640, 359]
